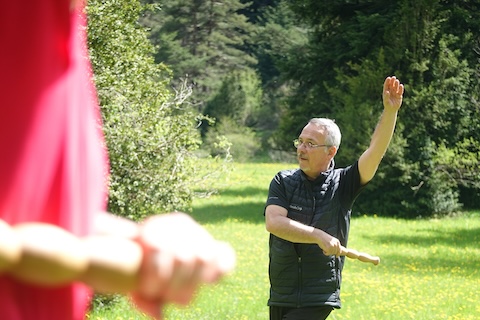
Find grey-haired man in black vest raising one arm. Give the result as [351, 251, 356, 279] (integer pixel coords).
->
[265, 76, 404, 320]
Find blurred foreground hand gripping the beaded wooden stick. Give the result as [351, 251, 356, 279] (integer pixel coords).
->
[131, 213, 235, 319]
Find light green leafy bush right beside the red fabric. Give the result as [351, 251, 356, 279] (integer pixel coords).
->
[87, 0, 208, 219]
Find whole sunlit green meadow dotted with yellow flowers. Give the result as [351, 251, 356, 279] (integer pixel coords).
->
[89, 163, 480, 320]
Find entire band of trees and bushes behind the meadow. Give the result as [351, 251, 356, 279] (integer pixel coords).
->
[88, 0, 480, 217]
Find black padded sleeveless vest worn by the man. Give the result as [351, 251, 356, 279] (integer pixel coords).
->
[267, 167, 359, 308]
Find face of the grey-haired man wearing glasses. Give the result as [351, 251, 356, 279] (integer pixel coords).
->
[297, 123, 337, 179]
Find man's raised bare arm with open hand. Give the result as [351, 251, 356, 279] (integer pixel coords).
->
[358, 76, 404, 184]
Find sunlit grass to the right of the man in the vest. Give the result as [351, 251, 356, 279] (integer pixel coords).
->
[333, 217, 480, 319]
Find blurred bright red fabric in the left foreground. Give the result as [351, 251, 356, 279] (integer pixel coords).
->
[0, 0, 107, 320]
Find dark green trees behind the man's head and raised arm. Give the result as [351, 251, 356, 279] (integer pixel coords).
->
[272, 0, 480, 217]
